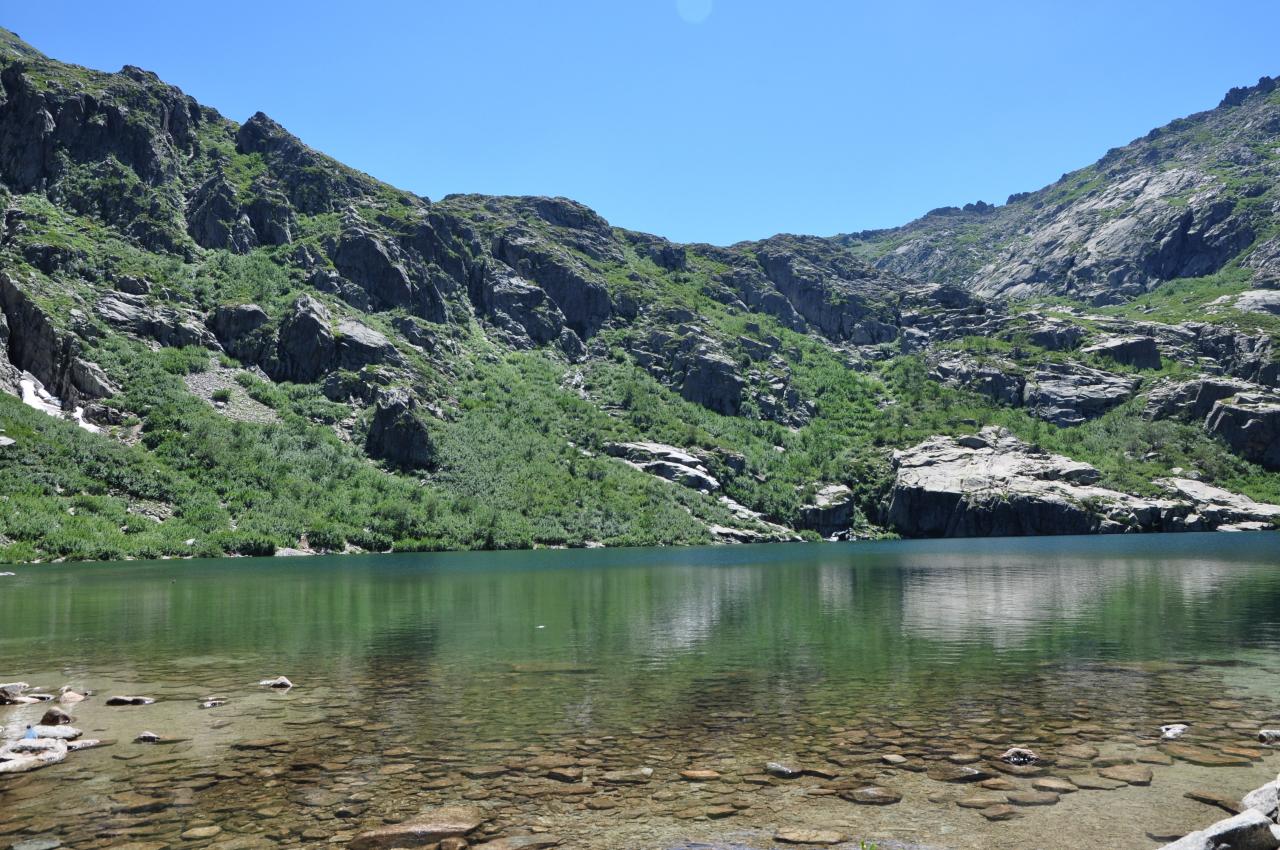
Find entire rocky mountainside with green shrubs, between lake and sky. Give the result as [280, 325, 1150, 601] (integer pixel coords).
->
[0, 26, 1280, 559]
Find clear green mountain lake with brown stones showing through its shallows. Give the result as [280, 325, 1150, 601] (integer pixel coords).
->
[0, 534, 1280, 850]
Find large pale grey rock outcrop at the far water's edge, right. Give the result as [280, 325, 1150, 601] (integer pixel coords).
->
[884, 426, 1280, 538]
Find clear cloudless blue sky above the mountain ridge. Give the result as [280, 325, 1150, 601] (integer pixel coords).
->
[0, 0, 1280, 243]
